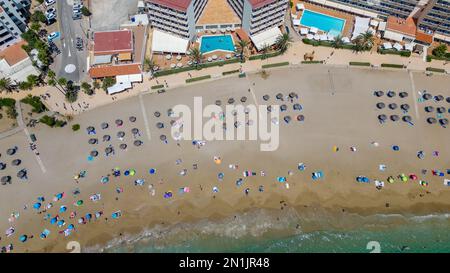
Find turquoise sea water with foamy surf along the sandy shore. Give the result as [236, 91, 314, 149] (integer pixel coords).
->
[90, 208, 450, 253]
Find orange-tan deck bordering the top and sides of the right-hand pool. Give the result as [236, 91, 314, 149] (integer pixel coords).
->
[291, 0, 355, 37]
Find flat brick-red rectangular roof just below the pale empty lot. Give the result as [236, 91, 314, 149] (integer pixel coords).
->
[94, 30, 133, 55]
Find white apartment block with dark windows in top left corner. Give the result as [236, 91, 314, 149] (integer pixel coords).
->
[0, 0, 31, 48]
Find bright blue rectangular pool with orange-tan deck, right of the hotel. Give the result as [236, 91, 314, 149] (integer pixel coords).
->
[300, 10, 345, 34]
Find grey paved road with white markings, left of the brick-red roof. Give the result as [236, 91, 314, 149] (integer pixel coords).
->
[55, 0, 87, 83]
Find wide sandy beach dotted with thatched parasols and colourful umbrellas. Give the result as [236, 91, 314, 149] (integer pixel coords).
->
[0, 66, 450, 252]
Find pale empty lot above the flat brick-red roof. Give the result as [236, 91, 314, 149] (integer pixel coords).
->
[90, 0, 138, 31]
